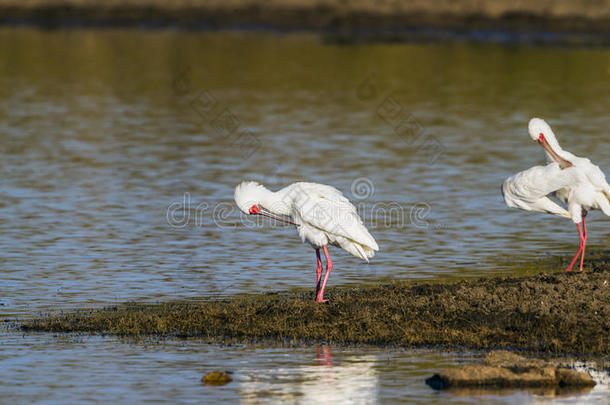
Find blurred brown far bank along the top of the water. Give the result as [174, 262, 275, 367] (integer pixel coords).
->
[0, 0, 610, 43]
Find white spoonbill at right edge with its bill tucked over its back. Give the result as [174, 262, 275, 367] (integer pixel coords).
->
[502, 118, 610, 271]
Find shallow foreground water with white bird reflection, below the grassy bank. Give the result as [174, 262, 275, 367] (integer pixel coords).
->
[0, 334, 608, 404]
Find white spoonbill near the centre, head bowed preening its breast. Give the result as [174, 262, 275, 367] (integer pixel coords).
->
[235, 181, 379, 302]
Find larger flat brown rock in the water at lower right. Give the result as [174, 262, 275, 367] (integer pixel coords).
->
[426, 350, 595, 389]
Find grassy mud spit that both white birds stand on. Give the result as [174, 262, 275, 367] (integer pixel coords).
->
[21, 259, 610, 358]
